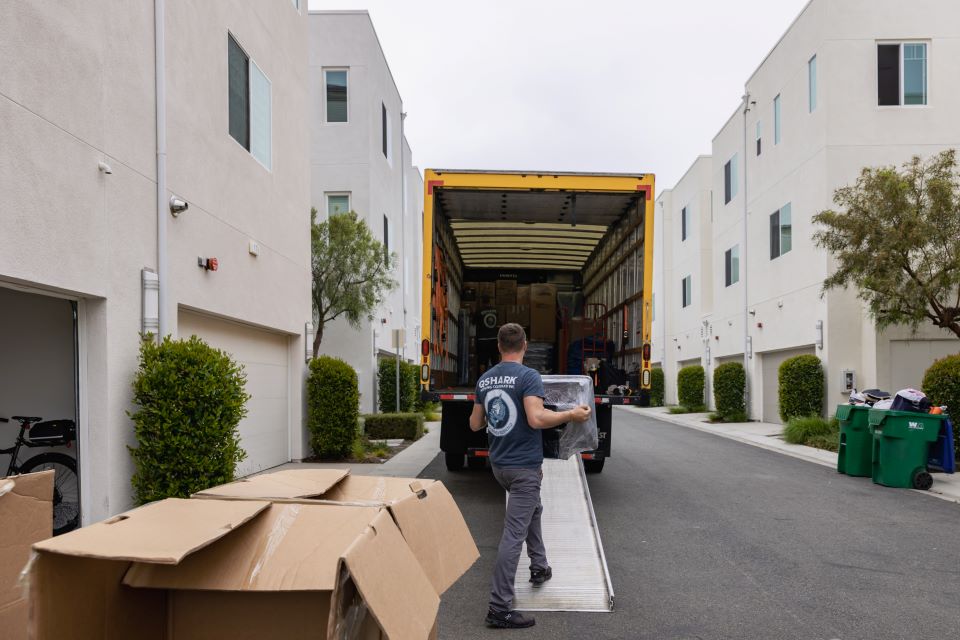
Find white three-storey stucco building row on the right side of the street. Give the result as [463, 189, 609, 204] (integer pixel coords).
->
[654, 0, 960, 422]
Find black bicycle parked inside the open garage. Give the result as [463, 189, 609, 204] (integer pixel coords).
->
[0, 416, 80, 536]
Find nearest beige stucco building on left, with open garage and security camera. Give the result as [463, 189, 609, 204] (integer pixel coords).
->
[0, 0, 310, 524]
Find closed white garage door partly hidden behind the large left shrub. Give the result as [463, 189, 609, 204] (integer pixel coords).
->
[178, 310, 290, 476]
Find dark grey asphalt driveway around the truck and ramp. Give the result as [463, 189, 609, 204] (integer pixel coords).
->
[422, 411, 960, 640]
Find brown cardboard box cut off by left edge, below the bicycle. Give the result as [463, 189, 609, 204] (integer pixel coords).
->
[0, 471, 54, 640]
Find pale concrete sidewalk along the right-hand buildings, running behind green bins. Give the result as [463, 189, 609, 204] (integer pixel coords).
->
[616, 406, 960, 503]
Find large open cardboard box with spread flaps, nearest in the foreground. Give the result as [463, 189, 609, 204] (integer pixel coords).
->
[29, 499, 440, 640]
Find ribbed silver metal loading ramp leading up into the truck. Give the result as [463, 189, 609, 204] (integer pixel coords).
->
[513, 456, 613, 611]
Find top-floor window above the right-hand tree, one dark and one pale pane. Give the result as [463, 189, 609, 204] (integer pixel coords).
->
[877, 42, 927, 106]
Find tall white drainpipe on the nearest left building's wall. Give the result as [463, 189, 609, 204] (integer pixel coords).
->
[153, 0, 170, 340]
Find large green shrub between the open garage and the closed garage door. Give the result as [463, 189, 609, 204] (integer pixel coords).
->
[127, 336, 250, 504]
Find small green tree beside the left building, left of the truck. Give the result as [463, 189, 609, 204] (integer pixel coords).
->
[310, 209, 397, 358]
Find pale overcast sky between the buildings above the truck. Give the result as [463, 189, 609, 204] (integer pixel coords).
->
[310, 0, 807, 189]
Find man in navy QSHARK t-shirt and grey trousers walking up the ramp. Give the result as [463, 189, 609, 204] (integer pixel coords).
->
[470, 323, 590, 629]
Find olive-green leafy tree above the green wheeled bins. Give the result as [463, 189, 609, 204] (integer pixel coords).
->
[813, 150, 960, 337]
